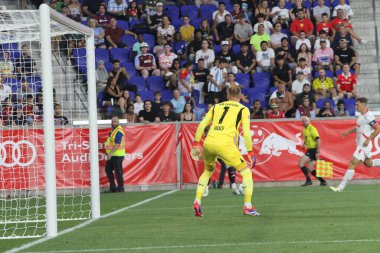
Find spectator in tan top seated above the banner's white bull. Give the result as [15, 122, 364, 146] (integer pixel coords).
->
[269, 83, 294, 117]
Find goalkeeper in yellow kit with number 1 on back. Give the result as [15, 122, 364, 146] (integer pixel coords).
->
[191, 87, 260, 217]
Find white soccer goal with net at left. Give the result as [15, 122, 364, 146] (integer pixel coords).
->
[0, 4, 100, 239]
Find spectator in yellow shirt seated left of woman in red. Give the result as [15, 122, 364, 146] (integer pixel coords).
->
[313, 68, 337, 100]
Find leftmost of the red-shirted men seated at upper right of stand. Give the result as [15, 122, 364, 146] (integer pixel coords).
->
[290, 10, 315, 46]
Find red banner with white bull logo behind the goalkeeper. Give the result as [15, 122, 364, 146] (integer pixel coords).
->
[181, 119, 380, 183]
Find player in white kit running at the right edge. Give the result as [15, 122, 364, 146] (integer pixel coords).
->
[330, 97, 380, 192]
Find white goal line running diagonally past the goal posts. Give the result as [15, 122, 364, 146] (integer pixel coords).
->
[5, 190, 178, 253]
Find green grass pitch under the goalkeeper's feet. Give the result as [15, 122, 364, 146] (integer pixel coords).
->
[0, 185, 380, 253]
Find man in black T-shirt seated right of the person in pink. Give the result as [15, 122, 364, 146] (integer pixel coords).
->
[334, 39, 360, 77]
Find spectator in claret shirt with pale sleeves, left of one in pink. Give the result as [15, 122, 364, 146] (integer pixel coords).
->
[135, 42, 160, 79]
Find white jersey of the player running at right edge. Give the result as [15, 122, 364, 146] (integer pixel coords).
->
[356, 110, 377, 146]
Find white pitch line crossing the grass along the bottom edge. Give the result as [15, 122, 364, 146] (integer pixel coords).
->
[25, 239, 380, 253]
